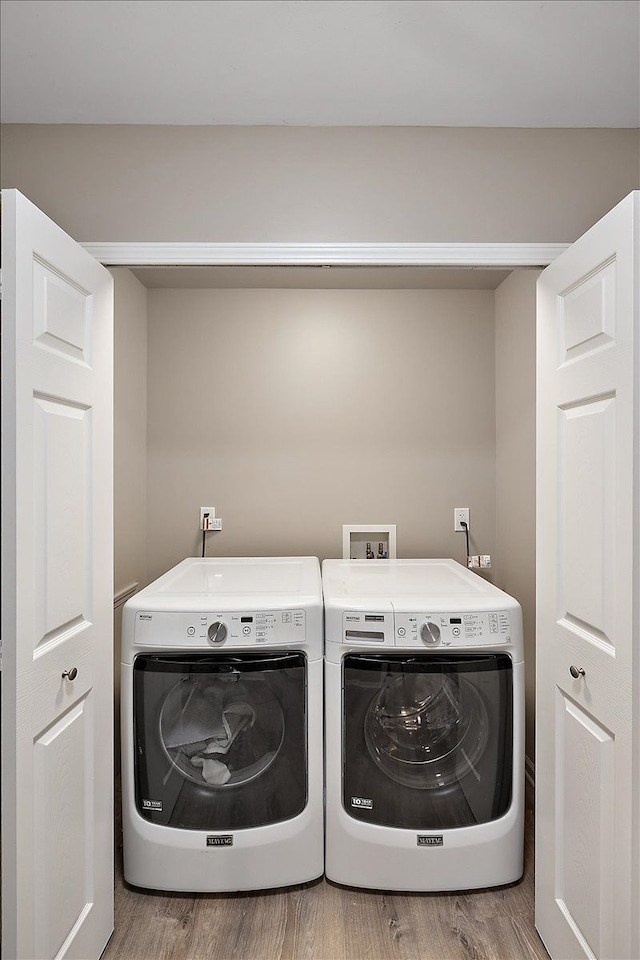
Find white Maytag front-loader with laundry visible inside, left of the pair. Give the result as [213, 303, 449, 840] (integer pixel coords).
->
[122, 557, 324, 892]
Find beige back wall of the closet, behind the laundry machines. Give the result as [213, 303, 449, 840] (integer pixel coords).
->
[147, 290, 495, 578]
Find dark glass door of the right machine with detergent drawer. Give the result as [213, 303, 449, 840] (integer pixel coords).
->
[343, 654, 513, 829]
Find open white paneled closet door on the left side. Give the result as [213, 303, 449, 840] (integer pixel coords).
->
[2, 190, 113, 960]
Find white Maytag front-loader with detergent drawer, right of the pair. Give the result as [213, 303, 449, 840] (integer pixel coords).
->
[322, 560, 524, 891]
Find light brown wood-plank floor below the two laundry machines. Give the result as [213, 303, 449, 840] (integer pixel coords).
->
[102, 788, 548, 960]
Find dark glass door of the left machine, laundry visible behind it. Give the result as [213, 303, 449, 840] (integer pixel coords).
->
[133, 653, 307, 830]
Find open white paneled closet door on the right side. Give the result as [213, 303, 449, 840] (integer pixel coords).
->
[536, 192, 640, 960]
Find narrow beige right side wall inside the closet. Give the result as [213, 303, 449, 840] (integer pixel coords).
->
[495, 270, 540, 759]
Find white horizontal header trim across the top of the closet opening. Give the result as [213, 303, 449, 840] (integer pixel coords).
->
[82, 242, 569, 267]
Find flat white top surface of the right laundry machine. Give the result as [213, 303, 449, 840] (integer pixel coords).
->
[322, 559, 511, 609]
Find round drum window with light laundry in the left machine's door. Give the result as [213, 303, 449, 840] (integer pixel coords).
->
[160, 674, 284, 787]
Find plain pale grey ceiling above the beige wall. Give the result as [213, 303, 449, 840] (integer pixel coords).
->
[0, 0, 640, 127]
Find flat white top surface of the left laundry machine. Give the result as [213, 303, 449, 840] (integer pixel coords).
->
[133, 557, 322, 609]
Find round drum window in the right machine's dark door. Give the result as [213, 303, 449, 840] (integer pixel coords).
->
[364, 673, 489, 790]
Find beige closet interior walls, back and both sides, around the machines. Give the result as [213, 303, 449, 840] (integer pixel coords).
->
[127, 269, 539, 757]
